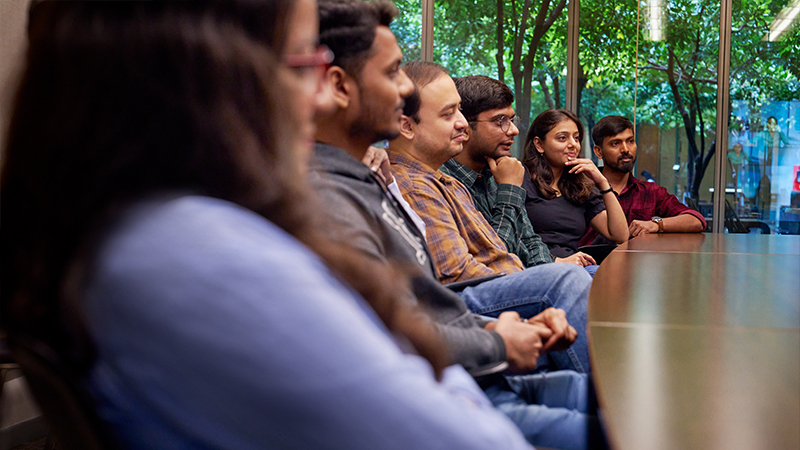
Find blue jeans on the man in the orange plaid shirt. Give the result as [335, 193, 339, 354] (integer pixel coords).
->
[461, 263, 592, 373]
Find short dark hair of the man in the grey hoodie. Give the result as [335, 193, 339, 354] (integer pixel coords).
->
[317, 0, 399, 79]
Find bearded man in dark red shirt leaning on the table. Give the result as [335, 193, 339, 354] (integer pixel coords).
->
[581, 116, 706, 245]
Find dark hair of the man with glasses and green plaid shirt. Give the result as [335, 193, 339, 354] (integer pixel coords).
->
[453, 75, 514, 123]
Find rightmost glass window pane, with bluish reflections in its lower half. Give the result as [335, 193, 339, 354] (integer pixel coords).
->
[725, 0, 800, 234]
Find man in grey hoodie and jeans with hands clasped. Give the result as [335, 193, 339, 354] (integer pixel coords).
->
[311, 4, 603, 448]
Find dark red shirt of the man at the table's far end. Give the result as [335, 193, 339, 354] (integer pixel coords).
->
[580, 174, 708, 245]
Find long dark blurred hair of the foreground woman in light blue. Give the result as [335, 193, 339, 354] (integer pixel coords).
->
[0, 0, 444, 373]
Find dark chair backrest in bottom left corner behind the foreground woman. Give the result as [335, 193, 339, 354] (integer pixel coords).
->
[8, 338, 118, 450]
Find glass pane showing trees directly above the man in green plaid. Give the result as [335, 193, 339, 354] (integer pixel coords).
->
[433, 0, 567, 153]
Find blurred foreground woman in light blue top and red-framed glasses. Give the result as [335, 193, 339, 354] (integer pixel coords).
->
[0, 0, 529, 449]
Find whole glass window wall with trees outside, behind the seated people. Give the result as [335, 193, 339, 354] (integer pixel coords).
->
[392, 0, 800, 234]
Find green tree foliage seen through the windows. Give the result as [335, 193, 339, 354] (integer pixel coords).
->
[395, 0, 800, 193]
